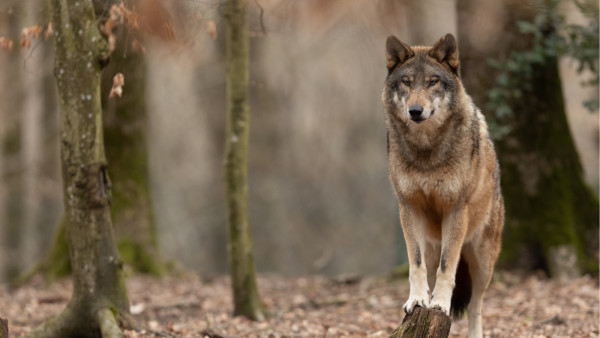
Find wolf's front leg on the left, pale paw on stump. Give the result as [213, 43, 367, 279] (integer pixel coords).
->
[400, 204, 430, 313]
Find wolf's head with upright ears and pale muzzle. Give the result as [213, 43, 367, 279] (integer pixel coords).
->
[382, 34, 462, 130]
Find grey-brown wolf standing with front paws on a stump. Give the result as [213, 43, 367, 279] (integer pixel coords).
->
[382, 34, 504, 337]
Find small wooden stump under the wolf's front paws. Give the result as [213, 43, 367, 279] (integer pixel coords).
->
[390, 307, 452, 338]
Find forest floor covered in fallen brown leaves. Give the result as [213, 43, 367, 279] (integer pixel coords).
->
[0, 272, 600, 338]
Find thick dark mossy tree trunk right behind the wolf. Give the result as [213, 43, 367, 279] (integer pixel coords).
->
[459, 0, 599, 277]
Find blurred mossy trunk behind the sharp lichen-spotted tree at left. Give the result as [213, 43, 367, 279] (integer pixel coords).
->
[28, 1, 169, 281]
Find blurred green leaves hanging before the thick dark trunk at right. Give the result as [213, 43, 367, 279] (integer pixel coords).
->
[487, 0, 599, 139]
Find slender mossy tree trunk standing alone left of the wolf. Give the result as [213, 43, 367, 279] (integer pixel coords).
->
[225, 0, 265, 320]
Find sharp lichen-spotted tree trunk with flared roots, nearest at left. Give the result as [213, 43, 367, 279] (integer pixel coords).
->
[27, 0, 131, 337]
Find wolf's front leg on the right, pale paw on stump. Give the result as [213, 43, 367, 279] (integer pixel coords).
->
[431, 205, 469, 315]
